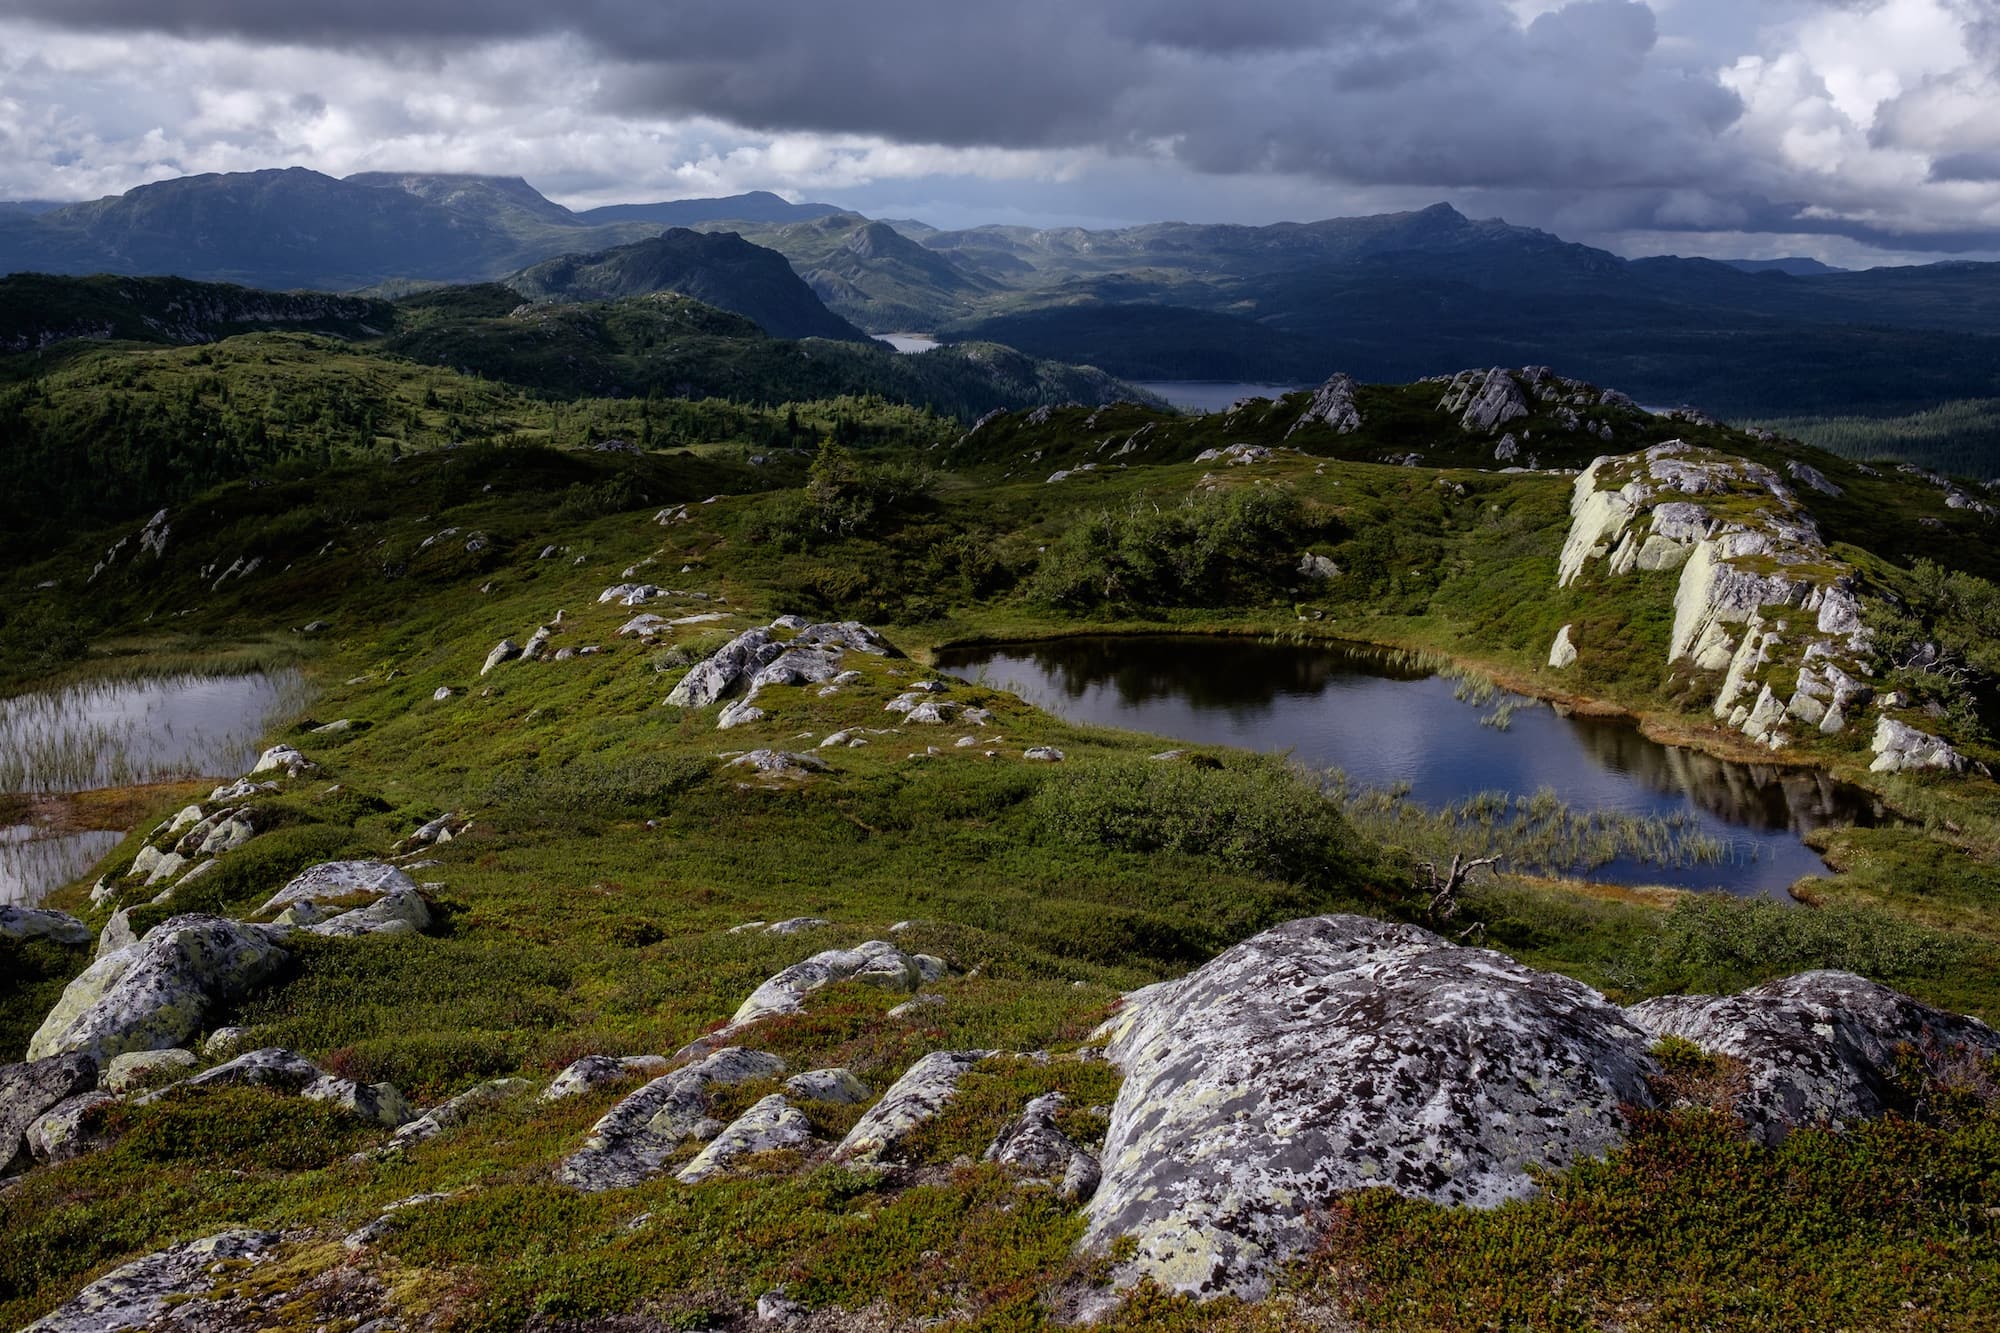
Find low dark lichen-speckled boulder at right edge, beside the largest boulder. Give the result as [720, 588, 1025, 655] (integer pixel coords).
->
[1628, 971, 2000, 1143]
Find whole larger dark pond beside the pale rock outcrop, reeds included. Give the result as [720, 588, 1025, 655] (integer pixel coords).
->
[938, 636, 1894, 901]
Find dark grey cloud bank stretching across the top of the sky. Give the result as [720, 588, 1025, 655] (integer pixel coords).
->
[0, 0, 1736, 186]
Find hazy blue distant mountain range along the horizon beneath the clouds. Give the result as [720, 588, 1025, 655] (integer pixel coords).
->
[0, 170, 2000, 416]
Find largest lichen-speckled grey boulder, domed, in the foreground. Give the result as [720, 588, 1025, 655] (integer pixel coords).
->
[1084, 917, 1656, 1299]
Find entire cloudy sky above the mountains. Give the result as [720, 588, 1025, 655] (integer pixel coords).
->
[0, 0, 2000, 266]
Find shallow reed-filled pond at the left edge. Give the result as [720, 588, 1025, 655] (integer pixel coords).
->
[0, 671, 306, 905]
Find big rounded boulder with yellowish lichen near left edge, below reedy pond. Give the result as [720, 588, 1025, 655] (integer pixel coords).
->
[28, 917, 290, 1065]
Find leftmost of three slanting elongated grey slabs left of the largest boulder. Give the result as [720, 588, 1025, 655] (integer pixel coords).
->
[556, 1047, 784, 1191]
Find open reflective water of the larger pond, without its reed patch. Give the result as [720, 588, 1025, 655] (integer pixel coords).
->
[940, 638, 1880, 895]
